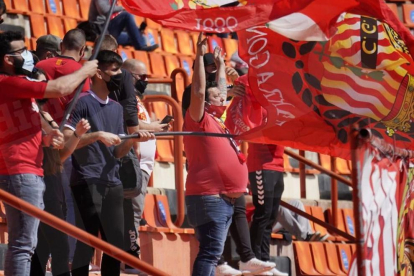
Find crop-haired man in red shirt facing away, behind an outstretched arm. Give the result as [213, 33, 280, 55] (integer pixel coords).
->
[36, 29, 90, 124]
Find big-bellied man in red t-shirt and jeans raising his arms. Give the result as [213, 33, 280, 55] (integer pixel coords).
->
[182, 33, 248, 276]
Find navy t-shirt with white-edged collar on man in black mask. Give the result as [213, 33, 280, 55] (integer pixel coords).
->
[66, 91, 124, 186]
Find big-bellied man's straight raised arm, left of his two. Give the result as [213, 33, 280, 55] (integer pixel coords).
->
[188, 33, 207, 122]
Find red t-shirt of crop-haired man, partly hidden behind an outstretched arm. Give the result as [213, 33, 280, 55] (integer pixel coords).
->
[36, 56, 90, 124]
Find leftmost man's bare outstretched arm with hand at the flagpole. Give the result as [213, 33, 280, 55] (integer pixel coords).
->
[44, 60, 98, 98]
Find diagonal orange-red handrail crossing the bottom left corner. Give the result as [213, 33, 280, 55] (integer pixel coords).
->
[0, 189, 169, 276]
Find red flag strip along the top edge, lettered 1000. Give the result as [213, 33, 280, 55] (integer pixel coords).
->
[122, 0, 358, 33]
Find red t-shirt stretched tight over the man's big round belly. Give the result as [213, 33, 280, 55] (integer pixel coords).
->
[183, 112, 248, 195]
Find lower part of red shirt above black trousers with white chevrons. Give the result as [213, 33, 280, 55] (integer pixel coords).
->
[247, 143, 285, 172]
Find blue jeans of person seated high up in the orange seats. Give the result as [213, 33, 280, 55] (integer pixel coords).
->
[108, 11, 147, 50]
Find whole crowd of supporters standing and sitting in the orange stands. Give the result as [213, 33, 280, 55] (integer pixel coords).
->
[0, 0, 327, 276]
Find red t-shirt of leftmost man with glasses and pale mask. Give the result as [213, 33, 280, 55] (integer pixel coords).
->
[0, 75, 47, 176]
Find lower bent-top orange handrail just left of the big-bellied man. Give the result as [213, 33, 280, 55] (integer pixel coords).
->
[144, 95, 185, 227]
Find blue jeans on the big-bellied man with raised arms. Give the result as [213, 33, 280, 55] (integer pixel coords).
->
[185, 195, 234, 276]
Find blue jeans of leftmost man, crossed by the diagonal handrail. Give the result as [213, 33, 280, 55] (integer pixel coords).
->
[0, 174, 45, 276]
